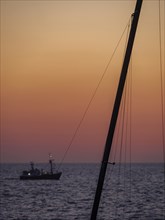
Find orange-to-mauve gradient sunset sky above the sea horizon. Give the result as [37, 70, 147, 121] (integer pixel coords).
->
[0, 0, 165, 162]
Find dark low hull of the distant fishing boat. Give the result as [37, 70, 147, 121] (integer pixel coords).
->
[20, 172, 62, 180]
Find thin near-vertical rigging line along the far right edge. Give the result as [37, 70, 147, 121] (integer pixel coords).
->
[159, 0, 165, 218]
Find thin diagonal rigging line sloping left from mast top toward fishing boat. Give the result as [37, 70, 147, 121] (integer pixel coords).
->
[59, 17, 131, 168]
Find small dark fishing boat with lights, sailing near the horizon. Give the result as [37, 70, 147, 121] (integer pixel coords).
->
[20, 158, 62, 180]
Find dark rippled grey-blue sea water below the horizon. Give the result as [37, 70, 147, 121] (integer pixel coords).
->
[0, 164, 165, 220]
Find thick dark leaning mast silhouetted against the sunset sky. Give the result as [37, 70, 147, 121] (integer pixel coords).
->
[91, 0, 143, 220]
